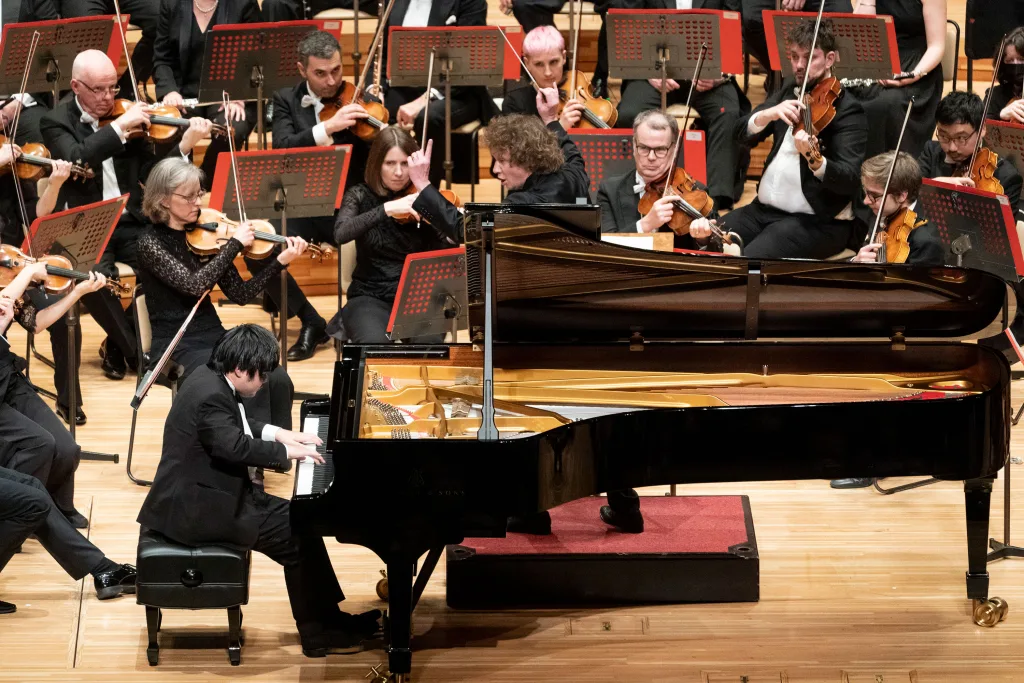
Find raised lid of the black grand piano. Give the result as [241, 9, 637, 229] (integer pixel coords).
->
[466, 204, 1017, 343]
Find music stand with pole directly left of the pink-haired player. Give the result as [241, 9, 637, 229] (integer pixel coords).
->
[387, 26, 505, 189]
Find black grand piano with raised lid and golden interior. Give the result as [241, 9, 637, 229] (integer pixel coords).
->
[292, 205, 1016, 680]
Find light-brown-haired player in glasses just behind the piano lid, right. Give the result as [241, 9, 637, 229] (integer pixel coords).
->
[852, 152, 945, 265]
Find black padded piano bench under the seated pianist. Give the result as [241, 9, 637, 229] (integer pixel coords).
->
[135, 528, 250, 667]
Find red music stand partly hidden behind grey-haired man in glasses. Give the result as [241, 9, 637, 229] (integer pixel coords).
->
[569, 128, 708, 200]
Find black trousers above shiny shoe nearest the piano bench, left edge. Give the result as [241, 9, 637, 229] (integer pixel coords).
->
[0, 467, 106, 581]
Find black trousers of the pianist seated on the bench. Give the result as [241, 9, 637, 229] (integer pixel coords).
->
[250, 488, 345, 636]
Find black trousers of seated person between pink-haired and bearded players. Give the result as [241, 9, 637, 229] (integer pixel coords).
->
[615, 80, 751, 208]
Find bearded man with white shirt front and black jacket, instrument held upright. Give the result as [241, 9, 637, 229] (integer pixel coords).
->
[690, 19, 867, 259]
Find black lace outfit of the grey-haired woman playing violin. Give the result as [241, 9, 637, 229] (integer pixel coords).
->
[137, 224, 295, 428]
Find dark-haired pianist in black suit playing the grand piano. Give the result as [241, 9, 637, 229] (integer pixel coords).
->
[138, 325, 380, 657]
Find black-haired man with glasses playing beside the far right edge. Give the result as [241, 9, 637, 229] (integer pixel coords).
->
[918, 91, 1022, 210]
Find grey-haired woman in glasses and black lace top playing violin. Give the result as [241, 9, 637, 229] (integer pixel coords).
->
[138, 159, 307, 429]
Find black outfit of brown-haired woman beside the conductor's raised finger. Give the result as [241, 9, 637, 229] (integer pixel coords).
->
[334, 183, 461, 344]
